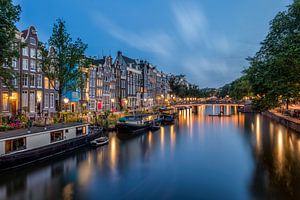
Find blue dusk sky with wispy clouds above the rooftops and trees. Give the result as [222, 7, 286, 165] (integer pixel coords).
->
[14, 0, 292, 87]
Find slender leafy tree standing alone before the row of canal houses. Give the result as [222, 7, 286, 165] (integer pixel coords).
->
[40, 19, 87, 111]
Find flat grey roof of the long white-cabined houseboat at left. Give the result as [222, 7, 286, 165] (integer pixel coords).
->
[0, 122, 88, 140]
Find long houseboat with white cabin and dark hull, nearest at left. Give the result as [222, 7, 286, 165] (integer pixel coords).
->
[0, 123, 101, 171]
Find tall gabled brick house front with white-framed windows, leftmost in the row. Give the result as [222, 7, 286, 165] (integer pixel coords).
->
[0, 26, 57, 118]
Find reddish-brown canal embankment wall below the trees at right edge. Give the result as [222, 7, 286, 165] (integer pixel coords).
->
[262, 110, 300, 133]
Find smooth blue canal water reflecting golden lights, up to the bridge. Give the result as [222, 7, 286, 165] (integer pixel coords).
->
[0, 105, 300, 200]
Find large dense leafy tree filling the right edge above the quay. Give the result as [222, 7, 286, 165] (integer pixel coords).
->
[245, 0, 300, 110]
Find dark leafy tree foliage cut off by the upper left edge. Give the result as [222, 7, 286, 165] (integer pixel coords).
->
[0, 0, 21, 89]
